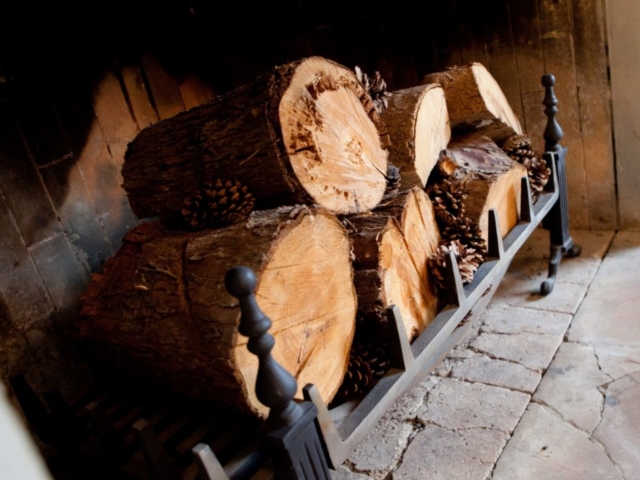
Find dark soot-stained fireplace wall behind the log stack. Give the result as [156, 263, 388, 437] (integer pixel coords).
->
[0, 0, 617, 402]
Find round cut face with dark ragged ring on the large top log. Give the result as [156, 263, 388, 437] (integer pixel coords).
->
[279, 57, 387, 213]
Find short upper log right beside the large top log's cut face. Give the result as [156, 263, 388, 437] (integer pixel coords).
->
[382, 84, 451, 189]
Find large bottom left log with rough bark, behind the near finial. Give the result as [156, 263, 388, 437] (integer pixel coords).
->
[80, 206, 356, 414]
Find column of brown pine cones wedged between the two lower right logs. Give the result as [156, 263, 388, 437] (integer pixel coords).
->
[427, 178, 487, 290]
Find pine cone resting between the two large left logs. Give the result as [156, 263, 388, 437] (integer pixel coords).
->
[182, 180, 255, 228]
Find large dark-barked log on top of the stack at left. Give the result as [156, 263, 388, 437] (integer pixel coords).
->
[122, 57, 388, 221]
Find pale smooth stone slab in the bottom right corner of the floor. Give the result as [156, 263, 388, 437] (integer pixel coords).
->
[593, 372, 640, 479]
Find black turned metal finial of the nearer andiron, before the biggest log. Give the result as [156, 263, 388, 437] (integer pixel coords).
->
[224, 267, 304, 426]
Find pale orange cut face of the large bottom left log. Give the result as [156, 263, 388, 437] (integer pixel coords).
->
[233, 208, 356, 411]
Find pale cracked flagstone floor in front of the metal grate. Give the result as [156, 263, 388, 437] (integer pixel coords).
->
[332, 230, 640, 480]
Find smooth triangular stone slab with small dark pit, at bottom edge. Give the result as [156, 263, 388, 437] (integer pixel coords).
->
[492, 403, 633, 480]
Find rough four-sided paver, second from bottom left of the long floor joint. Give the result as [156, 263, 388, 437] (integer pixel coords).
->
[417, 378, 531, 433]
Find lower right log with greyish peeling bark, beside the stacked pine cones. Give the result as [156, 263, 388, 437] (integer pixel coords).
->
[437, 135, 527, 241]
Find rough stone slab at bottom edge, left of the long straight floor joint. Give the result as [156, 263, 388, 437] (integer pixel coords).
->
[393, 425, 509, 480]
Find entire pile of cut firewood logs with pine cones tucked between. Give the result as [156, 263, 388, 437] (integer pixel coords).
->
[79, 57, 549, 415]
